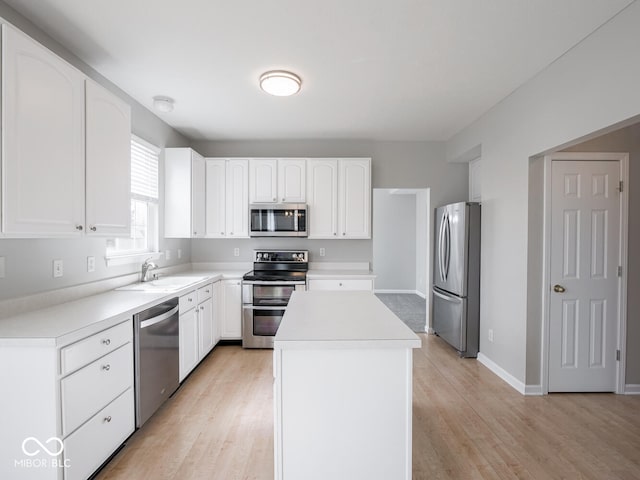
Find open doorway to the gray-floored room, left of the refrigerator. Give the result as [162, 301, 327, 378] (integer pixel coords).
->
[373, 188, 431, 332]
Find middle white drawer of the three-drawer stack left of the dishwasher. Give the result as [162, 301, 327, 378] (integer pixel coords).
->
[60, 343, 133, 435]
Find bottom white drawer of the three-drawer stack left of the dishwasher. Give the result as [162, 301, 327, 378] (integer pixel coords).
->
[64, 388, 135, 480]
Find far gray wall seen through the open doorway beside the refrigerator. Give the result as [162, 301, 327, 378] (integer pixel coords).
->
[373, 188, 417, 291]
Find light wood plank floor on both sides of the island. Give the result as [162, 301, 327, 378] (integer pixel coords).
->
[97, 335, 640, 480]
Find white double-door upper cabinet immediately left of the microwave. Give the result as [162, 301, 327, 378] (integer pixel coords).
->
[205, 158, 249, 238]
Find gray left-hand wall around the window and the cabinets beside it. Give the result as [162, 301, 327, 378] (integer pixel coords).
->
[0, 2, 191, 300]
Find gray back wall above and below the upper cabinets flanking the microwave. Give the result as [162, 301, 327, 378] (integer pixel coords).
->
[191, 140, 468, 262]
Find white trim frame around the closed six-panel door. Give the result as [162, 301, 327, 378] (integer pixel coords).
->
[540, 152, 629, 394]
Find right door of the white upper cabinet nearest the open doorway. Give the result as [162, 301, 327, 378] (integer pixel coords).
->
[338, 158, 371, 238]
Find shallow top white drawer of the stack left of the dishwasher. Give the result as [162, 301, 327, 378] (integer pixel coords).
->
[60, 320, 133, 375]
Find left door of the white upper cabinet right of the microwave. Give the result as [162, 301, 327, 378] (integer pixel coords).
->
[307, 159, 338, 238]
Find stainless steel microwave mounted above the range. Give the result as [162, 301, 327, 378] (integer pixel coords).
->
[249, 203, 307, 237]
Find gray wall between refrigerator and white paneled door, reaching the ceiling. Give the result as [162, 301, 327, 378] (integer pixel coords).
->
[447, 2, 640, 388]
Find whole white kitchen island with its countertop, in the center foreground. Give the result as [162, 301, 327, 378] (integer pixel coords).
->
[273, 291, 421, 480]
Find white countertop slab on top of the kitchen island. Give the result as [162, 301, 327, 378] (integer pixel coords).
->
[274, 291, 421, 349]
